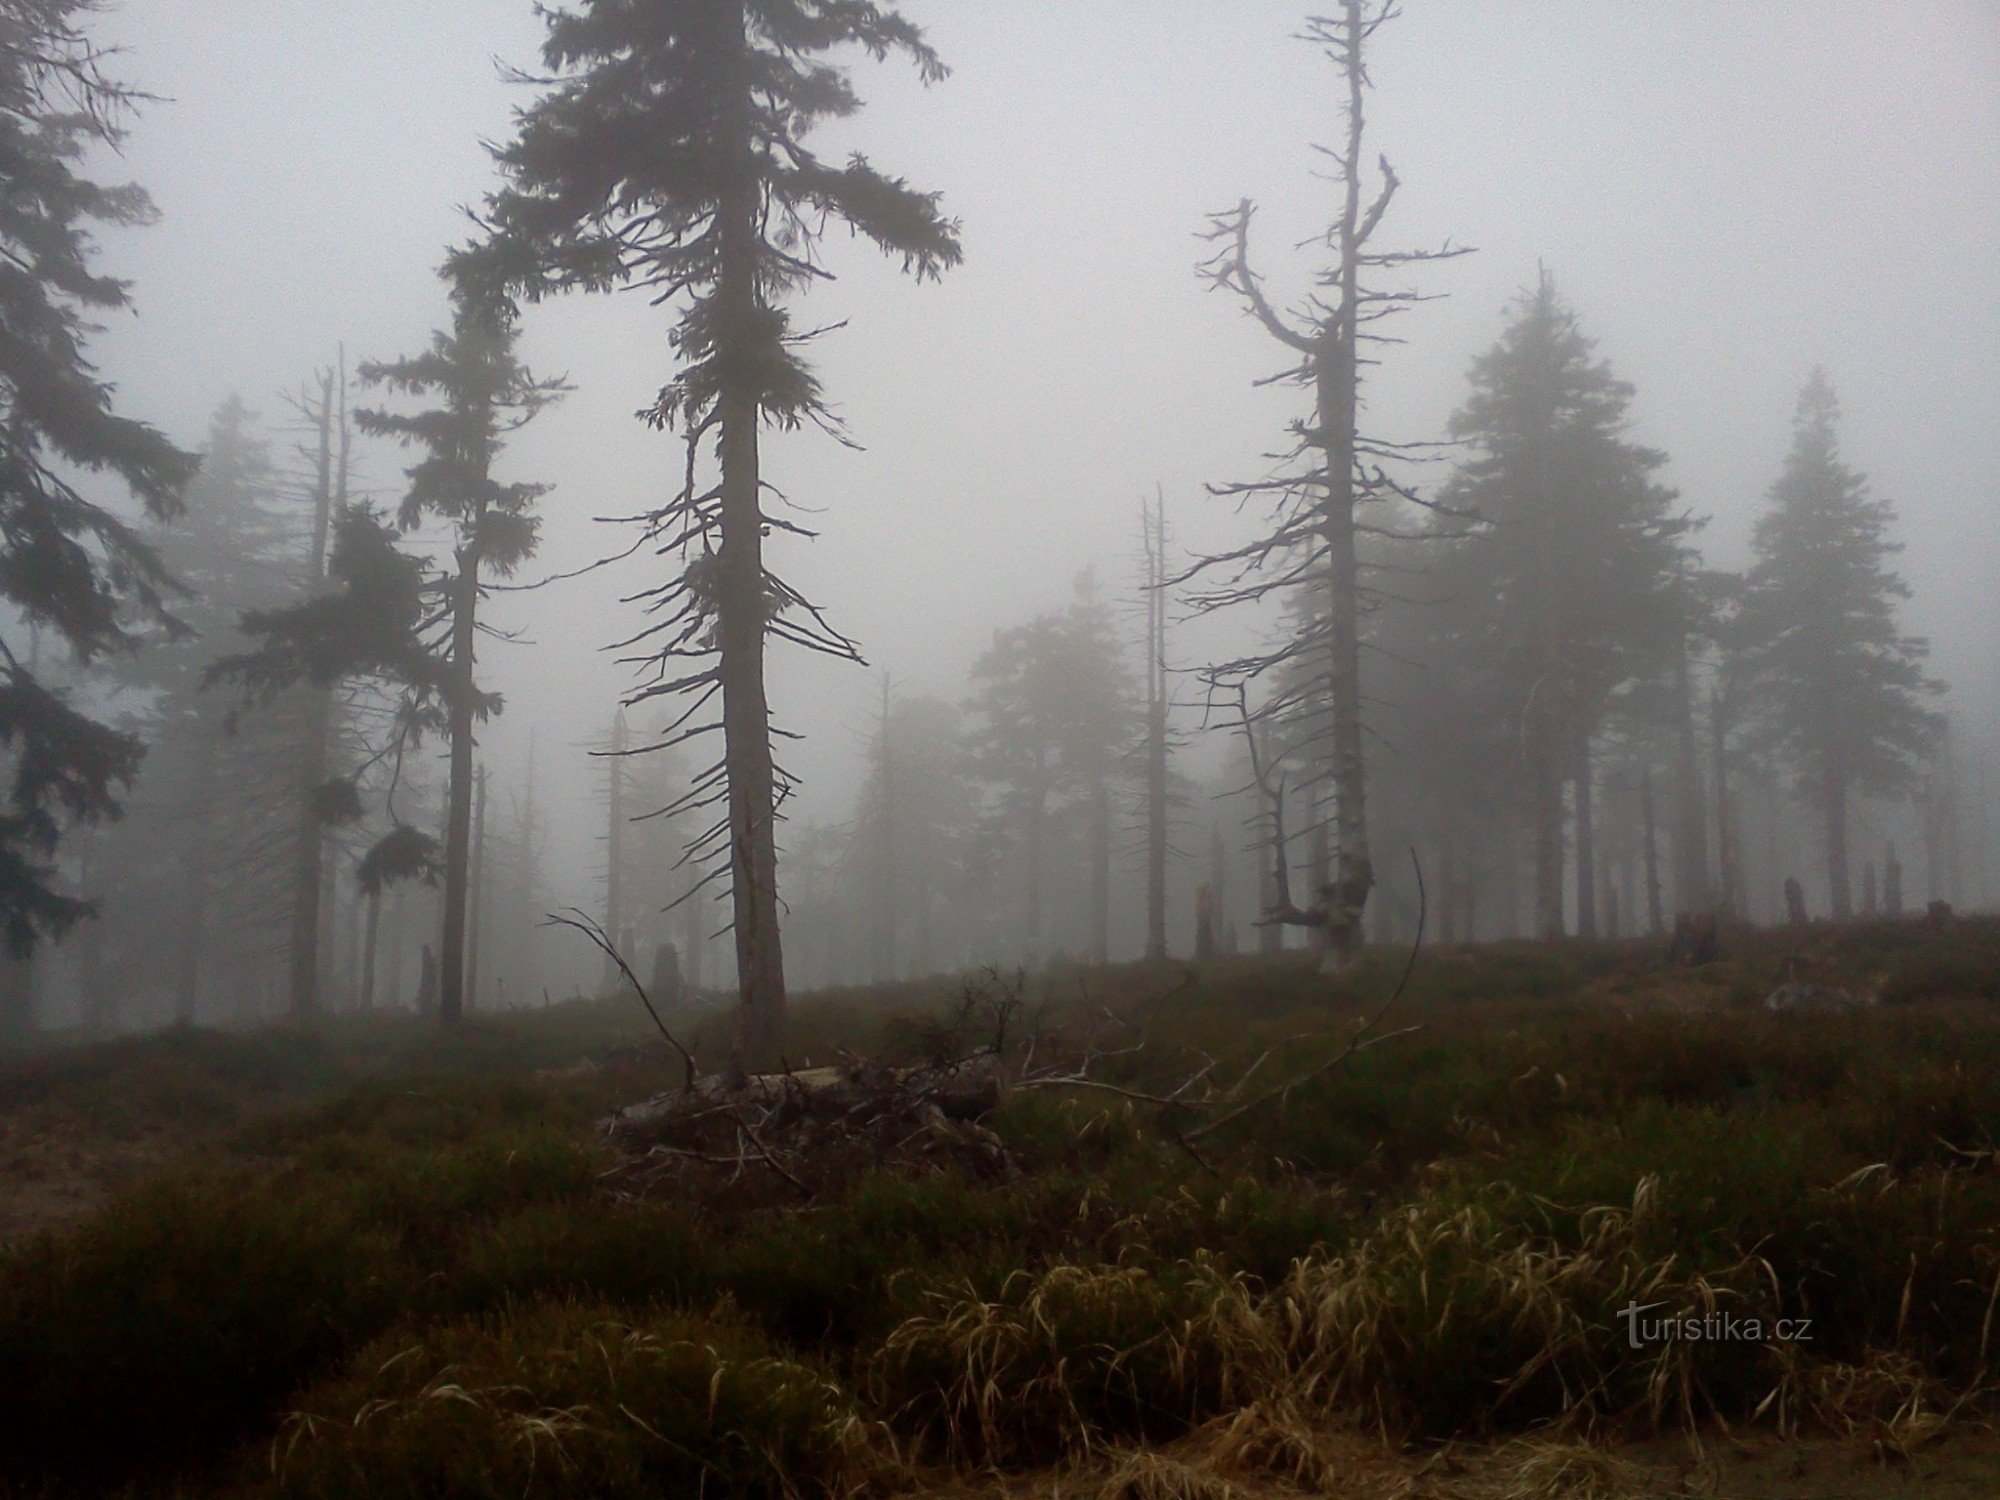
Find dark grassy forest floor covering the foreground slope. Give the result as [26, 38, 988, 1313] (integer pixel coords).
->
[0, 918, 2000, 1500]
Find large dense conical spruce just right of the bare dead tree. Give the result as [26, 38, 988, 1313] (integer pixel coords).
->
[1446, 270, 1692, 936]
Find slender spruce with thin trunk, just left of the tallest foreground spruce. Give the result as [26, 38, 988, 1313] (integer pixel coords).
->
[354, 288, 568, 1026]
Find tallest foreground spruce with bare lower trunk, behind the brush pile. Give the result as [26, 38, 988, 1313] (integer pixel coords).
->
[466, 0, 960, 1056]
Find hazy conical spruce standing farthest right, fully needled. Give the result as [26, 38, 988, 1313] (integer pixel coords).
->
[1738, 370, 1942, 920]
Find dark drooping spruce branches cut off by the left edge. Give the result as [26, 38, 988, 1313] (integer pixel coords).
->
[0, 0, 196, 956]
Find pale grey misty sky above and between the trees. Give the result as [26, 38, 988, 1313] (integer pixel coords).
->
[82, 0, 2000, 916]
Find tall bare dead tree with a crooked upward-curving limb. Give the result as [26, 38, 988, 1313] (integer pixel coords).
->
[1184, 0, 1466, 968]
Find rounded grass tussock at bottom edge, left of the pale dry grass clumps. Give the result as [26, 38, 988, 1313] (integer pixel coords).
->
[264, 1302, 886, 1500]
